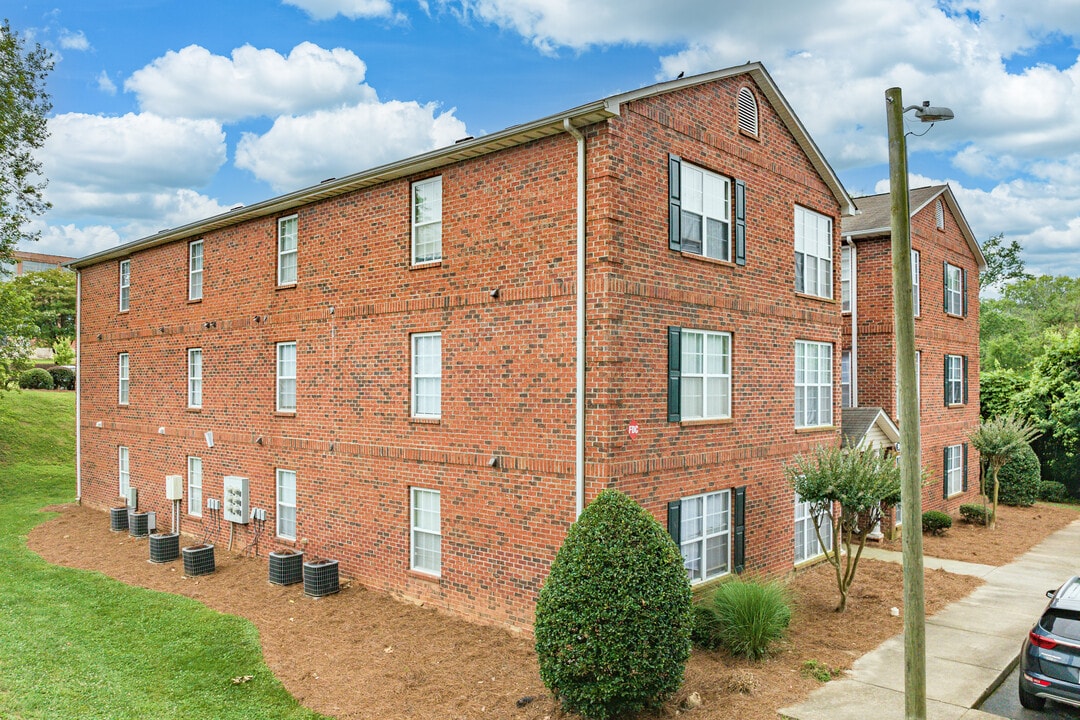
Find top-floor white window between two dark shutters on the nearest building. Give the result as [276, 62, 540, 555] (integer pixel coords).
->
[679, 160, 733, 262]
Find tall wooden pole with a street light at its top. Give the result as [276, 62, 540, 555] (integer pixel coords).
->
[885, 87, 953, 720]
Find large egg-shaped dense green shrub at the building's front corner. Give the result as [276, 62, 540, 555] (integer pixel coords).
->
[534, 490, 692, 720]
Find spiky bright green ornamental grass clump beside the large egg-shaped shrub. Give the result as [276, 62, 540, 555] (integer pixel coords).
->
[713, 579, 792, 660]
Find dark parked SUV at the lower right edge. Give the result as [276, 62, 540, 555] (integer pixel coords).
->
[1020, 576, 1080, 710]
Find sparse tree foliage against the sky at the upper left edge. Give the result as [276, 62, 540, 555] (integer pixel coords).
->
[0, 21, 53, 258]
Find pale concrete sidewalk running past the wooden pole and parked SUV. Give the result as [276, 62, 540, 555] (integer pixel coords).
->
[780, 520, 1080, 720]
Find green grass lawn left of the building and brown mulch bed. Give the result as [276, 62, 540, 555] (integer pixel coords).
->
[0, 391, 322, 720]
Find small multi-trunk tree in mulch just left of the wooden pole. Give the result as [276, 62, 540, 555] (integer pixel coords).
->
[785, 446, 900, 612]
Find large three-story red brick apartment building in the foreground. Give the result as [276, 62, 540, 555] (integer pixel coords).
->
[72, 64, 977, 626]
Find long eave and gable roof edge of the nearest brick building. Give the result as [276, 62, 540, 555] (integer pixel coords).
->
[68, 63, 855, 268]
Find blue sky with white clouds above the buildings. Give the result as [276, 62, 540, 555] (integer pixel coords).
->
[6, 0, 1080, 276]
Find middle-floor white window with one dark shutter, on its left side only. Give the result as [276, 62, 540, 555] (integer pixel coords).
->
[679, 328, 731, 420]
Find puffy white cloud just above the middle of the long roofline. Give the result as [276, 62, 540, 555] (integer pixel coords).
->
[237, 100, 467, 191]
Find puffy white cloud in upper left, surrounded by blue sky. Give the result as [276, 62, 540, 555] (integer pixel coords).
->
[124, 42, 376, 122]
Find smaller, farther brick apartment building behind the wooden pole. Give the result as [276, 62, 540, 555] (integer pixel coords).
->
[840, 185, 986, 535]
